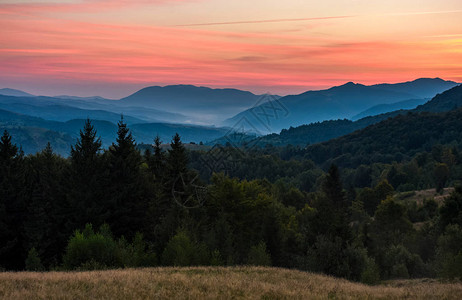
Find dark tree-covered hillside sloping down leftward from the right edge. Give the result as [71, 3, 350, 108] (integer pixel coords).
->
[306, 109, 462, 167]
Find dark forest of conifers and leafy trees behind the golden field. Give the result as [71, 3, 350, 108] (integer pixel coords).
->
[0, 111, 462, 284]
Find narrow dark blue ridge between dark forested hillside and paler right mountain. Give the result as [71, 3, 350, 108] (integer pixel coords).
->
[242, 85, 462, 147]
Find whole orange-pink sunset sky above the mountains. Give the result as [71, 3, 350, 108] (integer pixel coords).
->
[0, 0, 462, 99]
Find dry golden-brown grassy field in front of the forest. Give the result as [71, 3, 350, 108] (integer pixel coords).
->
[0, 267, 462, 299]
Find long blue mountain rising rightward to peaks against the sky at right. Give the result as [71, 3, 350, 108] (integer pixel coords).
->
[224, 78, 457, 132]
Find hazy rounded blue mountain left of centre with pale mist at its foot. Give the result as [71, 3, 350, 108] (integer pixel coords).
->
[119, 85, 266, 124]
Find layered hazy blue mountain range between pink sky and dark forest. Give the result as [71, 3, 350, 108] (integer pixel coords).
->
[0, 78, 459, 155]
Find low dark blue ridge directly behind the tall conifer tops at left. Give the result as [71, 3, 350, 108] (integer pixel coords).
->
[0, 109, 229, 156]
